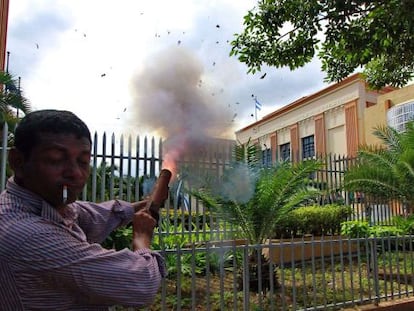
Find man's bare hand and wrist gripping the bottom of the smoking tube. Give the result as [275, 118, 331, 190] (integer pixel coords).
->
[132, 210, 157, 251]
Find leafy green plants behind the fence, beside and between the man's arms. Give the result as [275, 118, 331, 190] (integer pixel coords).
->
[102, 210, 242, 279]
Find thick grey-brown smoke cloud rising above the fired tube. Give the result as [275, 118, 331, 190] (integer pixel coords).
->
[132, 47, 234, 173]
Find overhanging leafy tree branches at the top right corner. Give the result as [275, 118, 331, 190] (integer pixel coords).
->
[230, 0, 414, 89]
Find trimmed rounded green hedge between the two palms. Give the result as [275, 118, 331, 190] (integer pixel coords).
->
[276, 204, 352, 238]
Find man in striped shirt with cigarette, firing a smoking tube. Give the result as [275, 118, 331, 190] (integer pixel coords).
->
[0, 110, 165, 311]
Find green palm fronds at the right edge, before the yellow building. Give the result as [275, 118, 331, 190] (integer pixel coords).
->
[344, 121, 414, 211]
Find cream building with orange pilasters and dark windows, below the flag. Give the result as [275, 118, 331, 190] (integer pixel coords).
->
[236, 74, 394, 163]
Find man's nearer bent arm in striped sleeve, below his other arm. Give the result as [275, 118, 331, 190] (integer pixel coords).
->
[14, 227, 165, 306]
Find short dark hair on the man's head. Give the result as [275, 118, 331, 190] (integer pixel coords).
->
[14, 109, 92, 156]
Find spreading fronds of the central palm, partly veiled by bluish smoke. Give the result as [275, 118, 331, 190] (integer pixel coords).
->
[193, 160, 322, 243]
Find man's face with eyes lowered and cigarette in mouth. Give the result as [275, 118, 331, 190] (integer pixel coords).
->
[14, 133, 91, 208]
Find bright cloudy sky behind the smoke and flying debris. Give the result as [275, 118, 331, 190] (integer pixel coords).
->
[7, 0, 327, 138]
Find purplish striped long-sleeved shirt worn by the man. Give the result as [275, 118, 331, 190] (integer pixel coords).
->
[0, 178, 165, 311]
